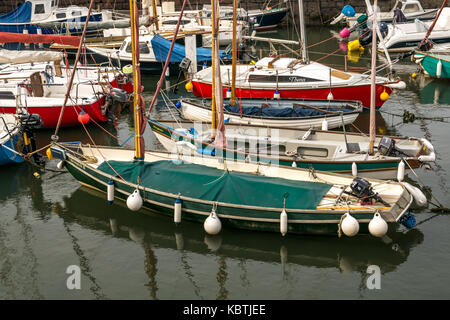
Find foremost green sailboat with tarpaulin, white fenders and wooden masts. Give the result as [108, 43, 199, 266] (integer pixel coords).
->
[49, 0, 420, 237]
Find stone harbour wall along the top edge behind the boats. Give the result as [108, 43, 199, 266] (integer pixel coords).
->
[0, 0, 450, 25]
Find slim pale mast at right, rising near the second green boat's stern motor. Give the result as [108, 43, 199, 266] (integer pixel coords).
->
[369, 0, 377, 155]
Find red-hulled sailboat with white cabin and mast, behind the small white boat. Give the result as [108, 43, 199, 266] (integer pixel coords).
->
[191, 0, 406, 108]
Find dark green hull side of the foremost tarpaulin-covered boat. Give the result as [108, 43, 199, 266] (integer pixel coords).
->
[57, 146, 413, 235]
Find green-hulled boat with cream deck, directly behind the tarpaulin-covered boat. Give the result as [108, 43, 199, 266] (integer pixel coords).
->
[148, 119, 435, 179]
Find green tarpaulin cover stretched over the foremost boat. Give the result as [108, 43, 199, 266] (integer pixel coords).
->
[98, 160, 331, 209]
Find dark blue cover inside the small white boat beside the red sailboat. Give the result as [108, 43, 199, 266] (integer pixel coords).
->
[224, 104, 354, 118]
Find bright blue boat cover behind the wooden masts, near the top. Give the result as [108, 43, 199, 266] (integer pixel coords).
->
[152, 34, 231, 62]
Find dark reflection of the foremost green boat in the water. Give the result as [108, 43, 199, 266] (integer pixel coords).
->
[60, 187, 424, 299]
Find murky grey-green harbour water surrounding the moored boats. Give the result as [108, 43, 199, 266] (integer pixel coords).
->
[0, 28, 450, 300]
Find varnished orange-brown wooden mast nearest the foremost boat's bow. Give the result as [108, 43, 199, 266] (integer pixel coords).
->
[130, 0, 145, 160]
